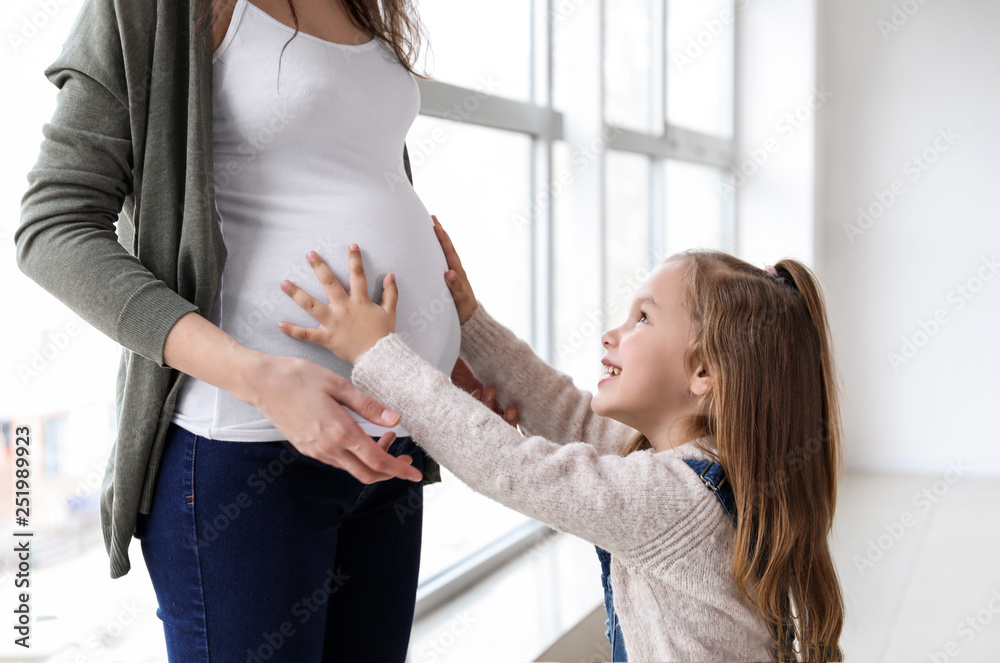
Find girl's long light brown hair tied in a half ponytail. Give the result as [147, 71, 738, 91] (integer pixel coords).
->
[621, 249, 844, 661]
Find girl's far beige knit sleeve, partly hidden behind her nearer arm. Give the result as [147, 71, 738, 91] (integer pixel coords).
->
[460, 303, 637, 455]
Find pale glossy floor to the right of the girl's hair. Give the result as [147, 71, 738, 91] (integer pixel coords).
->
[832, 468, 1000, 663]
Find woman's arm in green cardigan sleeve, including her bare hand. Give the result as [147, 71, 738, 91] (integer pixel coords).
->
[14, 2, 419, 483]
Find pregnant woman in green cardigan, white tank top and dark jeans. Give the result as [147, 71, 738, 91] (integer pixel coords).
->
[15, 0, 516, 663]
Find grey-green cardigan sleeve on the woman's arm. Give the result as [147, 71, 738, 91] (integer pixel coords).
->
[14, 2, 198, 367]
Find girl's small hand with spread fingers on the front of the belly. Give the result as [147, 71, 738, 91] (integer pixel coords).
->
[278, 244, 399, 363]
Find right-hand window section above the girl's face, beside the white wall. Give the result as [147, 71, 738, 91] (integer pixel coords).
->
[549, 0, 739, 392]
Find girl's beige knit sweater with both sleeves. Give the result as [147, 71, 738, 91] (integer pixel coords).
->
[352, 304, 770, 662]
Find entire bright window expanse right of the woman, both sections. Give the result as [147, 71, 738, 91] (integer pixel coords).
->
[407, 0, 737, 608]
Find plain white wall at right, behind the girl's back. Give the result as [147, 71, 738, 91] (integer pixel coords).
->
[816, 0, 1000, 474]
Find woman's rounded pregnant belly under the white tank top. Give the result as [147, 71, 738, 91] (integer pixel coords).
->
[215, 186, 460, 379]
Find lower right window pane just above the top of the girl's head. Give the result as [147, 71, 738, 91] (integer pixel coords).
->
[666, 161, 732, 255]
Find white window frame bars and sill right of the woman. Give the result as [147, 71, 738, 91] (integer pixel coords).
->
[416, 0, 740, 616]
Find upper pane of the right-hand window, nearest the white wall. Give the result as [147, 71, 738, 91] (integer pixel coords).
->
[666, 0, 735, 138]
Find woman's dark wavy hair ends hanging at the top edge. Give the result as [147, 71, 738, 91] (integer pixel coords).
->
[195, 0, 431, 80]
